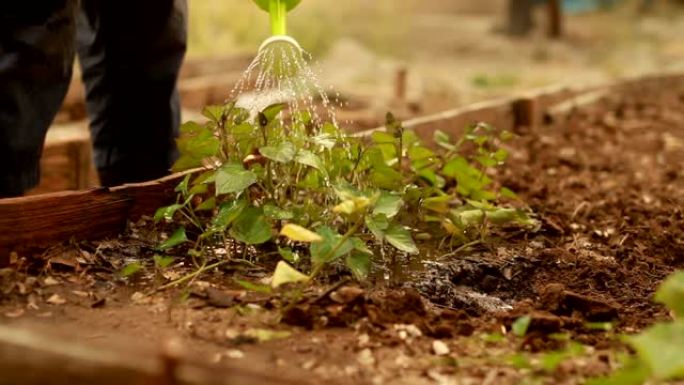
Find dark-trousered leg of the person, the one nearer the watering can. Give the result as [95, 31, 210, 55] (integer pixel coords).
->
[78, 0, 187, 186]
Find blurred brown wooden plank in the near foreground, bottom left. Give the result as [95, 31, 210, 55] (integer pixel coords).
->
[0, 325, 310, 385]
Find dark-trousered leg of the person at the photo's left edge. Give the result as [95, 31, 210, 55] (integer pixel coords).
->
[0, 0, 76, 197]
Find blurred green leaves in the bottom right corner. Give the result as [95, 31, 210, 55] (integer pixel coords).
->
[587, 271, 684, 385]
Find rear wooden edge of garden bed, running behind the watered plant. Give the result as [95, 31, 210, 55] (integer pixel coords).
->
[0, 74, 684, 267]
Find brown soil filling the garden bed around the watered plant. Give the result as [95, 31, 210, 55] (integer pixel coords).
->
[0, 79, 684, 384]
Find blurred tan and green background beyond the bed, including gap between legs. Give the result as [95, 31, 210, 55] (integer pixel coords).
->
[34, 0, 684, 193]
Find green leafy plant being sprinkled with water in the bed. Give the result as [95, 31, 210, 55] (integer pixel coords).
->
[155, 103, 536, 285]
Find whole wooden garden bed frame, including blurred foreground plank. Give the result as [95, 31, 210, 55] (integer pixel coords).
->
[0, 74, 684, 385]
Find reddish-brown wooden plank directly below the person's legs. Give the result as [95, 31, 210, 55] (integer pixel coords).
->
[0, 171, 192, 267]
